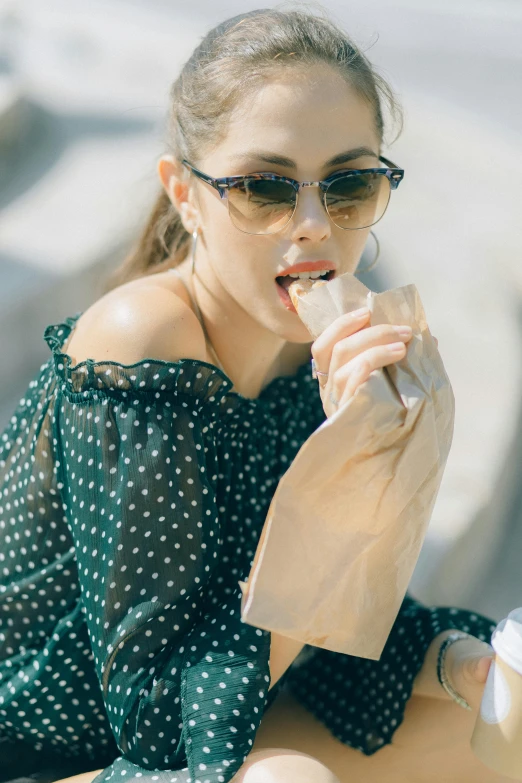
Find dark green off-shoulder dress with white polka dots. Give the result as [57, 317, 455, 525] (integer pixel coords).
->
[0, 313, 495, 783]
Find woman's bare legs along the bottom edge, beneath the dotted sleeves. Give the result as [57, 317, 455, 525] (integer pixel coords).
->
[51, 689, 510, 783]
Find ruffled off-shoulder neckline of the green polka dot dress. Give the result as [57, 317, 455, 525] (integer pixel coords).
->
[44, 311, 315, 412]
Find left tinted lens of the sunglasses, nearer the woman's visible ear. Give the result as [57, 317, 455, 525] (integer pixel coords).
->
[228, 178, 296, 234]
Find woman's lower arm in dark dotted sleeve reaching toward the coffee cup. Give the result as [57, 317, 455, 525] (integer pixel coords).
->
[280, 594, 495, 756]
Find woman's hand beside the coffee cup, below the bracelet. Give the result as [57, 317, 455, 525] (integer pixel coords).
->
[445, 636, 494, 712]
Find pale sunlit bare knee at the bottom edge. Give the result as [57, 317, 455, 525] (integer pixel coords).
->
[230, 748, 340, 783]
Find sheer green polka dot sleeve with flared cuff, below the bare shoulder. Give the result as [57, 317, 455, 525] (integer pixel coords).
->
[54, 363, 269, 780]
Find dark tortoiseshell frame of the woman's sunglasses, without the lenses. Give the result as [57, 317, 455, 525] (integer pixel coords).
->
[181, 156, 404, 234]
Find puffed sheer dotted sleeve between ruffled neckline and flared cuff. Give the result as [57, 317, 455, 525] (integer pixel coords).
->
[55, 393, 221, 767]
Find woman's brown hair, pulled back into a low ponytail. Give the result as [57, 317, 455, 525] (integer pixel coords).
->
[102, 4, 402, 290]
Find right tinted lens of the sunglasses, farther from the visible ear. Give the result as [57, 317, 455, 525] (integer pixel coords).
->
[326, 172, 391, 229]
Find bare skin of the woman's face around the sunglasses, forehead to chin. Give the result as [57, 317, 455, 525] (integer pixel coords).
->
[173, 66, 380, 342]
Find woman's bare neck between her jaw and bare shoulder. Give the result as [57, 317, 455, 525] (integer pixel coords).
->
[180, 264, 310, 399]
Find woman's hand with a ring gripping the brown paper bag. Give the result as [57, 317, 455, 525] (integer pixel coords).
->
[311, 308, 412, 417]
